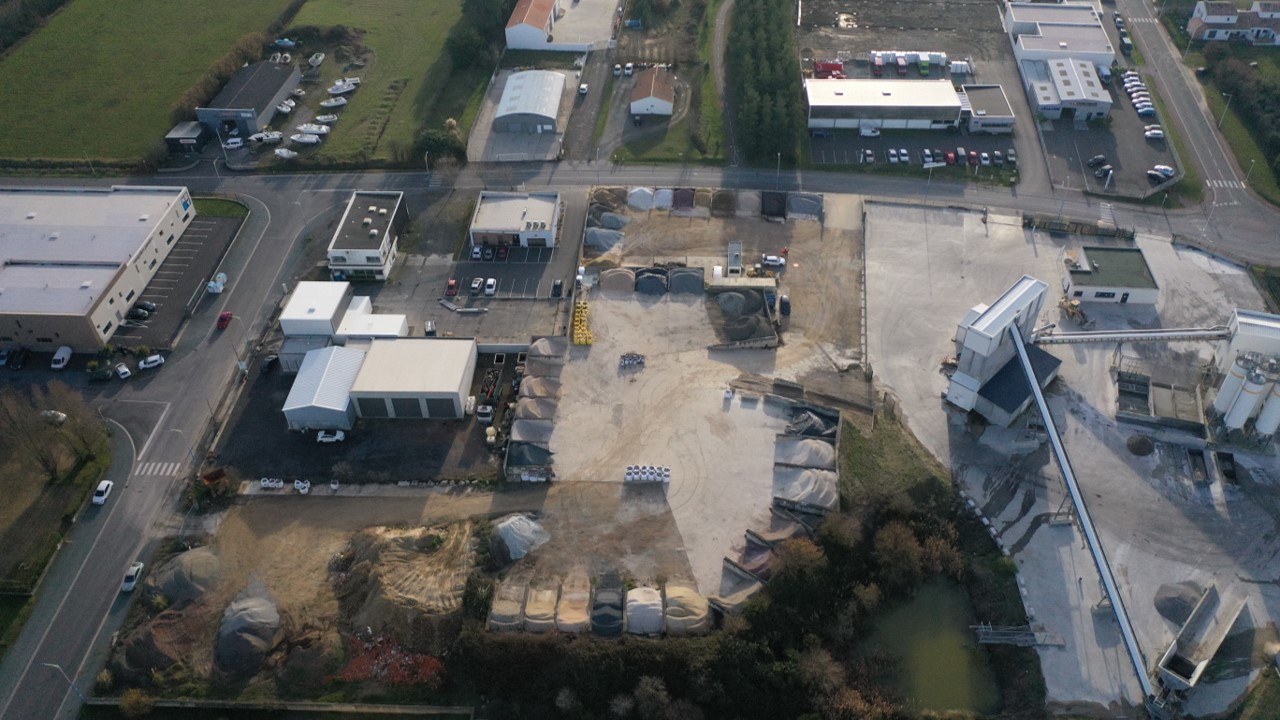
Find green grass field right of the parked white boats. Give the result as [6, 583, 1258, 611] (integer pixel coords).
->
[293, 0, 465, 163]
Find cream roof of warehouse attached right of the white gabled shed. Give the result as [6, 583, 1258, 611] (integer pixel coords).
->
[350, 337, 476, 395]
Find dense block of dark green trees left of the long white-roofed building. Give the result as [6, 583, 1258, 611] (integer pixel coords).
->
[724, 0, 805, 164]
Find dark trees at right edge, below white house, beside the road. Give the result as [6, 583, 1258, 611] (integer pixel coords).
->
[1204, 42, 1280, 179]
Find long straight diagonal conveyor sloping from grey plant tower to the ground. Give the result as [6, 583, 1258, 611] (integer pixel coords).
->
[1009, 323, 1157, 700]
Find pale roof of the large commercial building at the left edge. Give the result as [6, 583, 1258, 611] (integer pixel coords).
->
[0, 186, 191, 314]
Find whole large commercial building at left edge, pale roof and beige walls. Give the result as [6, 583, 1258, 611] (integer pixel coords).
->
[0, 186, 196, 351]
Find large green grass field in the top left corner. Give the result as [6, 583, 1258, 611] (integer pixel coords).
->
[0, 0, 289, 160]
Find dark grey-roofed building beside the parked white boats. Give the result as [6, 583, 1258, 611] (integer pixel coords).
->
[196, 60, 302, 141]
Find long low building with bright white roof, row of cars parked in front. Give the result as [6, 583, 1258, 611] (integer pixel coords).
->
[804, 79, 961, 129]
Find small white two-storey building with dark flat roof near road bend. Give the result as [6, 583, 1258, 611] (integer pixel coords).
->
[329, 191, 407, 281]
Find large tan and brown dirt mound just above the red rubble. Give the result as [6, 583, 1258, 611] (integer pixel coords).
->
[333, 521, 475, 653]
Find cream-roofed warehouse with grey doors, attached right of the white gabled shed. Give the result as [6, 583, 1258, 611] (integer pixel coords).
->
[351, 337, 476, 419]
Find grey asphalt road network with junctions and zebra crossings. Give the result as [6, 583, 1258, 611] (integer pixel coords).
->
[0, 18, 1280, 720]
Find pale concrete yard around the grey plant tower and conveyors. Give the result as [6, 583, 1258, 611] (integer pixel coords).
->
[867, 197, 1280, 712]
